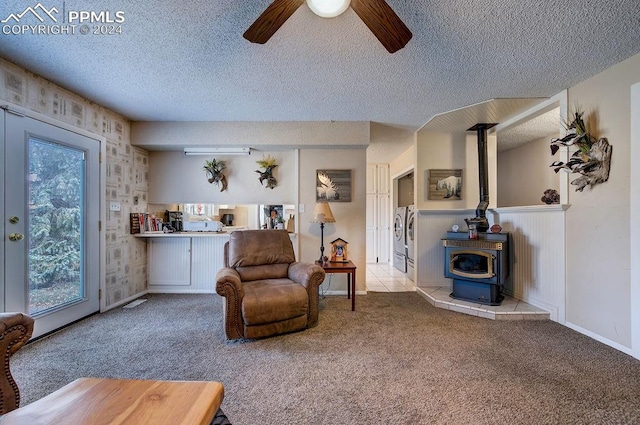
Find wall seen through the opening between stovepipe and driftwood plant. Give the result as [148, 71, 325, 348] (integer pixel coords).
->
[496, 137, 560, 207]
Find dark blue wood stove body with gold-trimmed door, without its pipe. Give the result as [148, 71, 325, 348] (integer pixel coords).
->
[442, 232, 509, 305]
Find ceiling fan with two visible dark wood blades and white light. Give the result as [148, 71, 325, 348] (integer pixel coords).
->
[243, 0, 412, 53]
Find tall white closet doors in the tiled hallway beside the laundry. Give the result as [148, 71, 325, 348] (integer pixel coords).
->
[366, 163, 392, 263]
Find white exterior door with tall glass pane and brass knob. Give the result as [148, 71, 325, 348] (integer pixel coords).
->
[2, 112, 100, 336]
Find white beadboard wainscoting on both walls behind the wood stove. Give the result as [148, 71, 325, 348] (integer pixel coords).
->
[417, 205, 566, 323]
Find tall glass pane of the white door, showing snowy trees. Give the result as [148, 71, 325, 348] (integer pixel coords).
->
[27, 137, 86, 316]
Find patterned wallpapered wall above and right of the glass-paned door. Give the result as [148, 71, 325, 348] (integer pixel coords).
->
[0, 59, 149, 309]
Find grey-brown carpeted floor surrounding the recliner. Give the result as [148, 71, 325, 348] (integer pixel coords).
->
[12, 293, 640, 425]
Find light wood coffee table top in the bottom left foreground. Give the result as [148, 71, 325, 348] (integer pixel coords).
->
[0, 378, 224, 425]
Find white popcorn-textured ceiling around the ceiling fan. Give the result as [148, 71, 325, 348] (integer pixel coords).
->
[0, 0, 640, 130]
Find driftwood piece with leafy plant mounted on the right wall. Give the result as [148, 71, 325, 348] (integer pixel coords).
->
[550, 111, 613, 192]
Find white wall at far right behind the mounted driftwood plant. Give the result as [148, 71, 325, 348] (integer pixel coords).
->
[566, 51, 640, 348]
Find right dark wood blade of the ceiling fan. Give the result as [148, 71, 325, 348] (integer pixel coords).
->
[351, 0, 413, 53]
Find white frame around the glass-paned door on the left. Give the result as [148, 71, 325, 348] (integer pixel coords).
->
[0, 101, 107, 313]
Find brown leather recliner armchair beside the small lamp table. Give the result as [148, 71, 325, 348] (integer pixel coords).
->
[216, 230, 325, 339]
